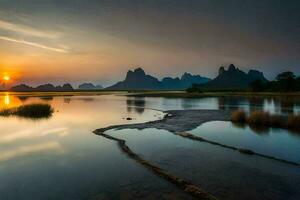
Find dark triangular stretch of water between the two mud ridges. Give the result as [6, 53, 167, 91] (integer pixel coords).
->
[108, 127, 300, 200]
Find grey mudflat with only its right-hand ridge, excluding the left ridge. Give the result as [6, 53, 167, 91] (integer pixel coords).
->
[93, 110, 300, 166]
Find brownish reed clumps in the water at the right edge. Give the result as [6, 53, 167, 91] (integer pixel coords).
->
[231, 110, 300, 132]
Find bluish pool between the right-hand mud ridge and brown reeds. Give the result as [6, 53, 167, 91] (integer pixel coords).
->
[191, 121, 300, 162]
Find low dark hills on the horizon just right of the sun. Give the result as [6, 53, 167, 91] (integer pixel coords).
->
[10, 83, 74, 92]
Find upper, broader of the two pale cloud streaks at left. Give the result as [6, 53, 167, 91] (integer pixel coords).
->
[0, 20, 61, 39]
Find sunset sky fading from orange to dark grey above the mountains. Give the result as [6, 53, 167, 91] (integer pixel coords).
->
[0, 0, 300, 86]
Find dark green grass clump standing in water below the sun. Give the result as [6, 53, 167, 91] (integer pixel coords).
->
[0, 104, 54, 119]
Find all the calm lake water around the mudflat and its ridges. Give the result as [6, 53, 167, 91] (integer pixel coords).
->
[0, 93, 300, 200]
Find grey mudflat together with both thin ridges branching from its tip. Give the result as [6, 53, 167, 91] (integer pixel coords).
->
[94, 110, 300, 200]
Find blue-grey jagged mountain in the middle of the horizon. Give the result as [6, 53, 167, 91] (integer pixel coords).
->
[106, 68, 210, 90]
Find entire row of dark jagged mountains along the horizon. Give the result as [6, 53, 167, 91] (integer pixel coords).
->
[11, 64, 268, 91]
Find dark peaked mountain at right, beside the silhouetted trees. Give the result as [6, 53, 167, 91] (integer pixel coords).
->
[199, 64, 268, 89]
